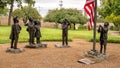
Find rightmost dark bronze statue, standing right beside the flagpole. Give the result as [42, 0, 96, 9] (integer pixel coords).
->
[98, 22, 109, 54]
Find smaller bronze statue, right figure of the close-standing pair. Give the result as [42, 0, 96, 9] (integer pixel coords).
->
[34, 20, 41, 44]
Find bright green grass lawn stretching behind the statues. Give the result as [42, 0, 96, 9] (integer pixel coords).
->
[0, 26, 120, 43]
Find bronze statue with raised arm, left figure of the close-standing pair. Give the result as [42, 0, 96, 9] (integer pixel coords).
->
[23, 17, 35, 45]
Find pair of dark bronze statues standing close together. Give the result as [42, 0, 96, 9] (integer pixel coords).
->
[23, 17, 43, 48]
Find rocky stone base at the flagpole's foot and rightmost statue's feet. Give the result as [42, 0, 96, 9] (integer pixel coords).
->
[84, 50, 109, 62]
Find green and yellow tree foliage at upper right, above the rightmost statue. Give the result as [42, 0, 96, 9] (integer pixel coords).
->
[99, 0, 120, 30]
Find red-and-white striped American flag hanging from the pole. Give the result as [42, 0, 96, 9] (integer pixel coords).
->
[84, 0, 95, 30]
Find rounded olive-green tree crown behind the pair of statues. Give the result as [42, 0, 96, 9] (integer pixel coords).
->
[12, 6, 42, 19]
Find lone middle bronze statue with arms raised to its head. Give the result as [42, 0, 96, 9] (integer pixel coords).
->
[62, 19, 70, 46]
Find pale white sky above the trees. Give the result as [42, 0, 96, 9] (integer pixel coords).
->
[13, 0, 100, 17]
